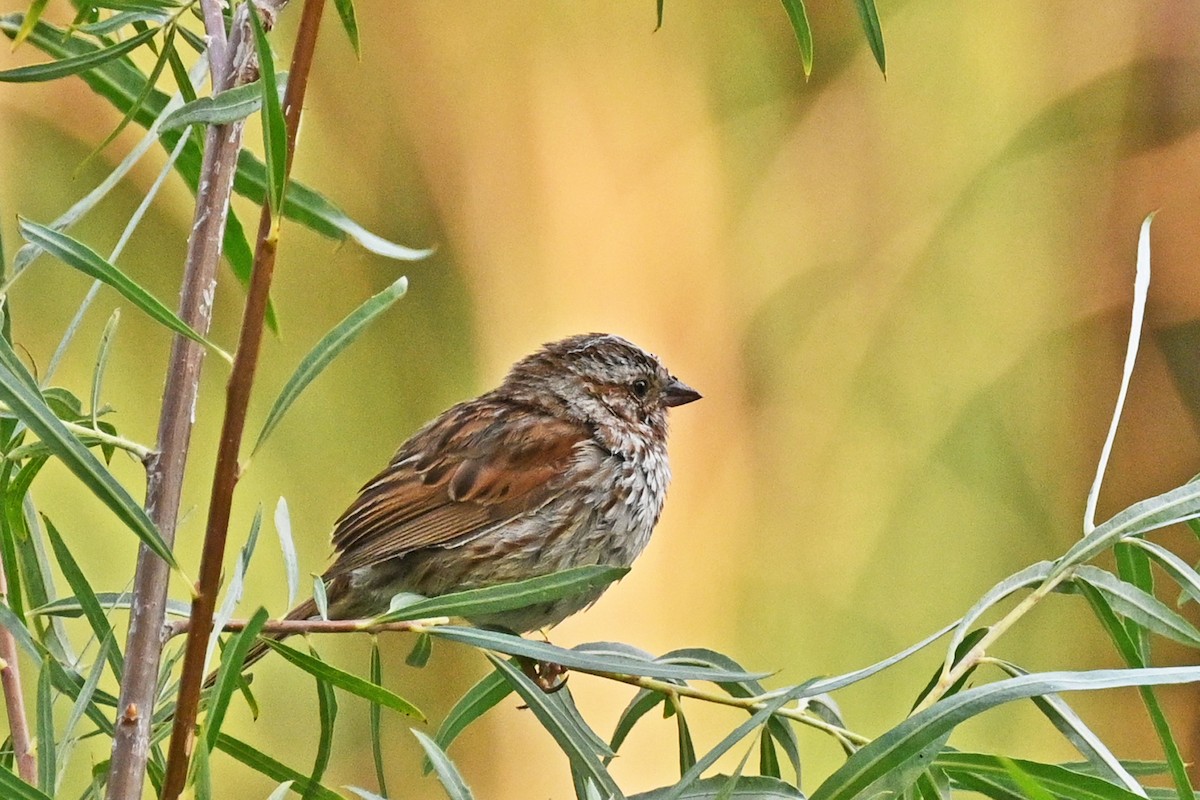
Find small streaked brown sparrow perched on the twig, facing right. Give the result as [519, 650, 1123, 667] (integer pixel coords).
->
[230, 333, 700, 676]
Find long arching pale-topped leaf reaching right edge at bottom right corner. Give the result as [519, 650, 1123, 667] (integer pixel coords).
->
[811, 666, 1200, 800]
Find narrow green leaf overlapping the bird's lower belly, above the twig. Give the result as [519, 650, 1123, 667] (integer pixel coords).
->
[376, 565, 629, 622]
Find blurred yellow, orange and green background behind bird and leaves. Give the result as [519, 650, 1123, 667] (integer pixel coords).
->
[0, 0, 1200, 800]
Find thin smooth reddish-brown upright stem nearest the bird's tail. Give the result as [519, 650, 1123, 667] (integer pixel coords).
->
[162, 0, 325, 800]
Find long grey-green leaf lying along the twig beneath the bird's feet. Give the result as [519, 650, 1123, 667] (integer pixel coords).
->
[428, 625, 766, 682]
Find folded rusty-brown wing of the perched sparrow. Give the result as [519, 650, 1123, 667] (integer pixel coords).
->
[330, 401, 590, 573]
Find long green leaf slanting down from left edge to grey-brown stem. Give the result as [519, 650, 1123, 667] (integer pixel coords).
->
[0, 352, 178, 569]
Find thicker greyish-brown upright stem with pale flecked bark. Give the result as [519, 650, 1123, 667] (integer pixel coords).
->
[106, 0, 242, 800]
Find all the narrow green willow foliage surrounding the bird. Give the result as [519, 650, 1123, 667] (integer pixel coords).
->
[0, 0, 1200, 800]
